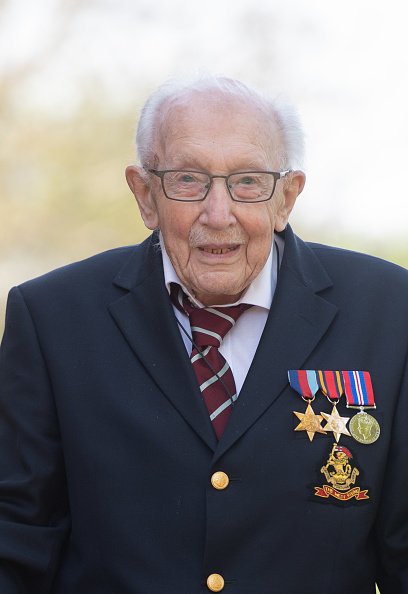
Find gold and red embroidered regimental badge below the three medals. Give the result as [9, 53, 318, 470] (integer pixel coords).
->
[314, 442, 369, 501]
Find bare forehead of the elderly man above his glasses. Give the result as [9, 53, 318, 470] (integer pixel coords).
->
[157, 92, 280, 167]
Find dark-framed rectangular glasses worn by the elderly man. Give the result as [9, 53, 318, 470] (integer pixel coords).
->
[147, 169, 291, 202]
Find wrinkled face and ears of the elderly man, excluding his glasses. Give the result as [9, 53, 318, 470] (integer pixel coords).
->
[127, 96, 303, 305]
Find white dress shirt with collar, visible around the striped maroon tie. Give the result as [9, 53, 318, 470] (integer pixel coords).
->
[160, 235, 284, 394]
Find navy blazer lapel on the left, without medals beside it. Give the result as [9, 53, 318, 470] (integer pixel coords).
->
[109, 235, 217, 450]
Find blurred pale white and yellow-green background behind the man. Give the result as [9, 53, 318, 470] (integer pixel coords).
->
[0, 0, 408, 335]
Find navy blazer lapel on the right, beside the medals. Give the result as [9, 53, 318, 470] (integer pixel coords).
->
[216, 228, 337, 458]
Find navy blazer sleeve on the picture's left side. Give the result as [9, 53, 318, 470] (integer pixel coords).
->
[0, 288, 69, 594]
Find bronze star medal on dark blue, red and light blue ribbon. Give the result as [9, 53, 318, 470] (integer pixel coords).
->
[288, 369, 326, 441]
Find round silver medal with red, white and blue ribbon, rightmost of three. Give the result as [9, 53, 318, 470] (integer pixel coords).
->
[342, 371, 380, 445]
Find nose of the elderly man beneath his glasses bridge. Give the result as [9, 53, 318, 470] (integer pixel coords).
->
[200, 178, 236, 229]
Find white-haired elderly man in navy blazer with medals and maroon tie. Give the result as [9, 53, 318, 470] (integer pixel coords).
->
[0, 78, 408, 594]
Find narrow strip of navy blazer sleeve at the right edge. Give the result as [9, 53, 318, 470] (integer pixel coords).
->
[376, 352, 408, 594]
